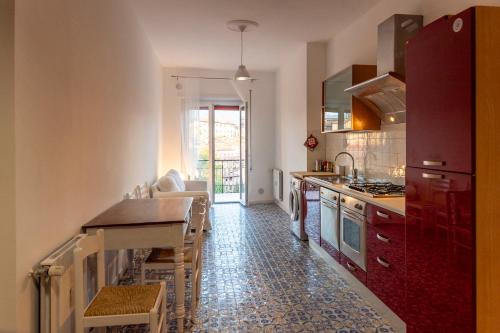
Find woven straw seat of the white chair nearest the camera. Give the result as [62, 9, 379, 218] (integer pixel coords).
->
[85, 284, 160, 317]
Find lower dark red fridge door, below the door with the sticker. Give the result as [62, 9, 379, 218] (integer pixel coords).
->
[405, 168, 475, 333]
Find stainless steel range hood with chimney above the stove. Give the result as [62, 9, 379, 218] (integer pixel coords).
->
[344, 14, 423, 124]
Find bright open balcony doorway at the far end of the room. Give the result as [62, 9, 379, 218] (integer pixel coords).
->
[193, 104, 248, 206]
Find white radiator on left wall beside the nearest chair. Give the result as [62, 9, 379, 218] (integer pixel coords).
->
[35, 234, 85, 333]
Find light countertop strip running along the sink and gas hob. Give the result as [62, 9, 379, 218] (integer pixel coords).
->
[304, 174, 405, 216]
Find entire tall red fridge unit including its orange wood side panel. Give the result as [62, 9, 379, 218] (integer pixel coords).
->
[405, 6, 500, 333]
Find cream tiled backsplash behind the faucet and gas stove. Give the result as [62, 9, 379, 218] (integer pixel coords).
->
[326, 124, 406, 184]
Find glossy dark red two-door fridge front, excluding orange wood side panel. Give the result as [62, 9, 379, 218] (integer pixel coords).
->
[405, 8, 475, 333]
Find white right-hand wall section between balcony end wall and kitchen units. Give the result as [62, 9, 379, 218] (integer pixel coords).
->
[275, 43, 307, 211]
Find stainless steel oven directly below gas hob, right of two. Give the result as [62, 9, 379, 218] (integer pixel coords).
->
[340, 194, 366, 271]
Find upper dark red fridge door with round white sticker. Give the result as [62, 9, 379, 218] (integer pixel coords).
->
[406, 9, 474, 173]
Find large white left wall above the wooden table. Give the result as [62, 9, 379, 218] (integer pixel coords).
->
[14, 0, 162, 333]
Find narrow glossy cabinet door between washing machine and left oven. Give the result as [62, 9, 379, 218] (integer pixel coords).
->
[302, 181, 321, 245]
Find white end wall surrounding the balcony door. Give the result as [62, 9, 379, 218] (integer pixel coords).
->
[159, 68, 275, 204]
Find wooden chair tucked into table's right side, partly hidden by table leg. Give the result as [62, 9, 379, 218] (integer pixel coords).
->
[141, 200, 208, 319]
